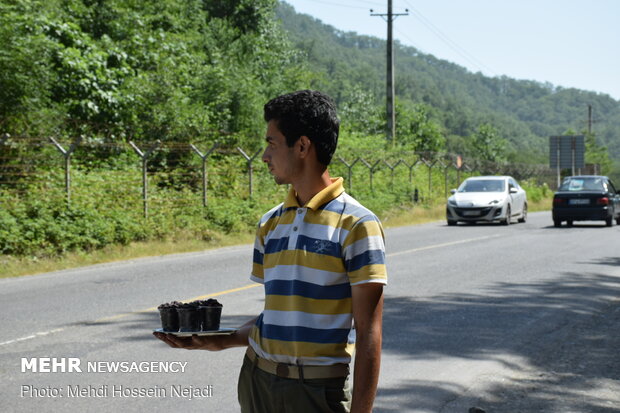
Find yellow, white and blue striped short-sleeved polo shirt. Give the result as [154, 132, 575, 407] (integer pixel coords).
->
[249, 178, 387, 365]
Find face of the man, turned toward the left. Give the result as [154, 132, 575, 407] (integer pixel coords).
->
[263, 120, 299, 185]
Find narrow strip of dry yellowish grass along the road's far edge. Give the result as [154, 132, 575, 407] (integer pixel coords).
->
[0, 198, 551, 278]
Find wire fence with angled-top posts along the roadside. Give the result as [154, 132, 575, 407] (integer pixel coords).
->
[0, 134, 556, 216]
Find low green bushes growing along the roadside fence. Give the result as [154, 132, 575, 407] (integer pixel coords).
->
[0, 145, 550, 257]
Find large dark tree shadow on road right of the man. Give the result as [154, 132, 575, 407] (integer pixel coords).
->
[376, 264, 620, 413]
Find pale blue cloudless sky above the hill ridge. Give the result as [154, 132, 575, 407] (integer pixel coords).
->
[285, 0, 620, 101]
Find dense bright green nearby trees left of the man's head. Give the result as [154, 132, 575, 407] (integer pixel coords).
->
[0, 0, 305, 148]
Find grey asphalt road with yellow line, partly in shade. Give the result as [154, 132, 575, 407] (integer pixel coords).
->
[0, 213, 620, 413]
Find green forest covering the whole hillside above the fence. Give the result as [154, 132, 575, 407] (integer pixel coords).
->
[0, 0, 620, 172]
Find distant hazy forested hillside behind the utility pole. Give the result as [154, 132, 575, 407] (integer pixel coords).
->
[277, 3, 620, 163]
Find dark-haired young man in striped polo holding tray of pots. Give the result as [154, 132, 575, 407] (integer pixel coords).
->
[156, 90, 387, 413]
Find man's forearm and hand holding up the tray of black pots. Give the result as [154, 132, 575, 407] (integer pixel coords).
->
[153, 317, 258, 351]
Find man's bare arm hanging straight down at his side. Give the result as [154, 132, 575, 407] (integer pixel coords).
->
[351, 283, 383, 413]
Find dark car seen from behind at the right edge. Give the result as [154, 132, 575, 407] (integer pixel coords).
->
[553, 175, 620, 227]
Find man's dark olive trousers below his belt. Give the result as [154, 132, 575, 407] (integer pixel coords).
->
[237, 356, 351, 413]
